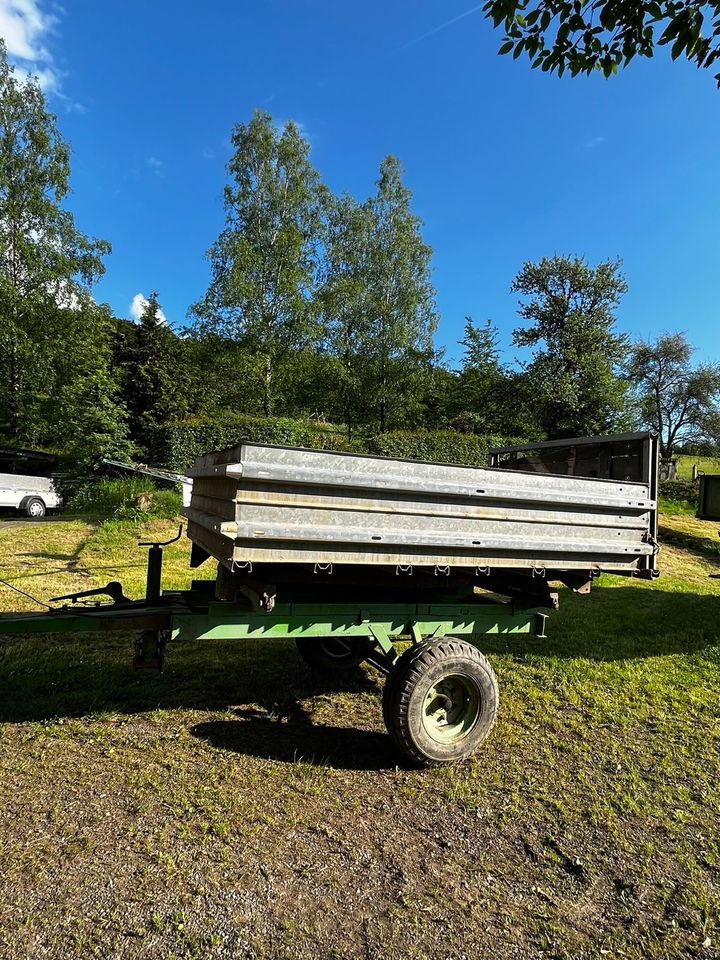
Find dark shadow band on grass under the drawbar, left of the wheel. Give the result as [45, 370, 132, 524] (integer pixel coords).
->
[0, 633, 382, 723]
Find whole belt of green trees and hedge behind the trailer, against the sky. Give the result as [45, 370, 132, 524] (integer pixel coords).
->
[0, 62, 720, 469]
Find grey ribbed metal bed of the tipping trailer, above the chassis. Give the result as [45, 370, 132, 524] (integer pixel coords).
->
[187, 434, 657, 578]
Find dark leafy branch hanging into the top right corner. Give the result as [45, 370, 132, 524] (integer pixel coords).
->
[483, 0, 720, 86]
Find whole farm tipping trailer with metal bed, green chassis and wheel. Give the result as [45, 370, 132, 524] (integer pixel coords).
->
[0, 434, 658, 765]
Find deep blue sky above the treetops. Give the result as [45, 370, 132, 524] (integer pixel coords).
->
[0, 0, 720, 368]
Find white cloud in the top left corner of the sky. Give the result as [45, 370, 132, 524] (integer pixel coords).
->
[0, 0, 60, 93]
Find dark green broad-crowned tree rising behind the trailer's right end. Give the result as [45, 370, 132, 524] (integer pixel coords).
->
[512, 256, 627, 438]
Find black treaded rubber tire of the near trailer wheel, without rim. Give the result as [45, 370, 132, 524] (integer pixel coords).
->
[383, 637, 500, 767]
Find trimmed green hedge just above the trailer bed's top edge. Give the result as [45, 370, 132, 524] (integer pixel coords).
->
[152, 416, 520, 470]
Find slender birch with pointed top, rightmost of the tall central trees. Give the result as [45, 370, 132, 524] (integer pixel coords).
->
[363, 156, 437, 431]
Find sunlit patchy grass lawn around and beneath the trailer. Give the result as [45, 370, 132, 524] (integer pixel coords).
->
[0, 516, 720, 960]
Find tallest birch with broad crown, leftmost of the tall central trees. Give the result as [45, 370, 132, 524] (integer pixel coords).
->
[192, 111, 320, 415]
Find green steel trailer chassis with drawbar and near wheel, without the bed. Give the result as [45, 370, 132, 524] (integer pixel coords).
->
[0, 532, 547, 765]
